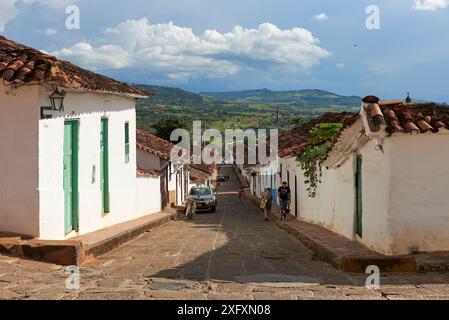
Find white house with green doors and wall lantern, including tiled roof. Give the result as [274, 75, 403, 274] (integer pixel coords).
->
[0, 36, 164, 240]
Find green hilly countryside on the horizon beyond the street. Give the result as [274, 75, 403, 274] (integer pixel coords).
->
[137, 85, 361, 132]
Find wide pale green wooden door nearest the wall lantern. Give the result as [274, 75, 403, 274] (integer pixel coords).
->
[63, 121, 78, 234]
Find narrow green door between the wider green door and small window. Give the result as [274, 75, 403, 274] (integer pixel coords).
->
[100, 119, 109, 215]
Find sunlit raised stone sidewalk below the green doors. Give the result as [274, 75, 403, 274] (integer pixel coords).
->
[0, 208, 177, 266]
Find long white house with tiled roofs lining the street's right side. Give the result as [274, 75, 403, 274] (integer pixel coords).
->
[252, 96, 449, 255]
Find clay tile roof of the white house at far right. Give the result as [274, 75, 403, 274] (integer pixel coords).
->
[368, 103, 449, 135]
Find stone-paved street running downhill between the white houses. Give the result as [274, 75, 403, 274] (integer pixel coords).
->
[0, 169, 449, 299]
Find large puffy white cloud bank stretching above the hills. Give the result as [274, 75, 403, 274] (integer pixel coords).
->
[52, 18, 330, 80]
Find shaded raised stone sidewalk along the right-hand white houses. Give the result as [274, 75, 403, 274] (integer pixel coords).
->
[248, 197, 416, 273]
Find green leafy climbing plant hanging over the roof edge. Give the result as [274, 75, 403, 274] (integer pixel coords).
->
[298, 123, 343, 198]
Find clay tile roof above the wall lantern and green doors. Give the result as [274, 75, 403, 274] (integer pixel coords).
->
[0, 35, 152, 97]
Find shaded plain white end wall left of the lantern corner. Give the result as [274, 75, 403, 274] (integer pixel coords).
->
[0, 81, 39, 236]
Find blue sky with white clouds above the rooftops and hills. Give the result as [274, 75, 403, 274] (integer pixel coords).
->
[0, 0, 449, 102]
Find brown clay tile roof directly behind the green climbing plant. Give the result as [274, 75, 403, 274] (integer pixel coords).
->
[278, 112, 359, 158]
